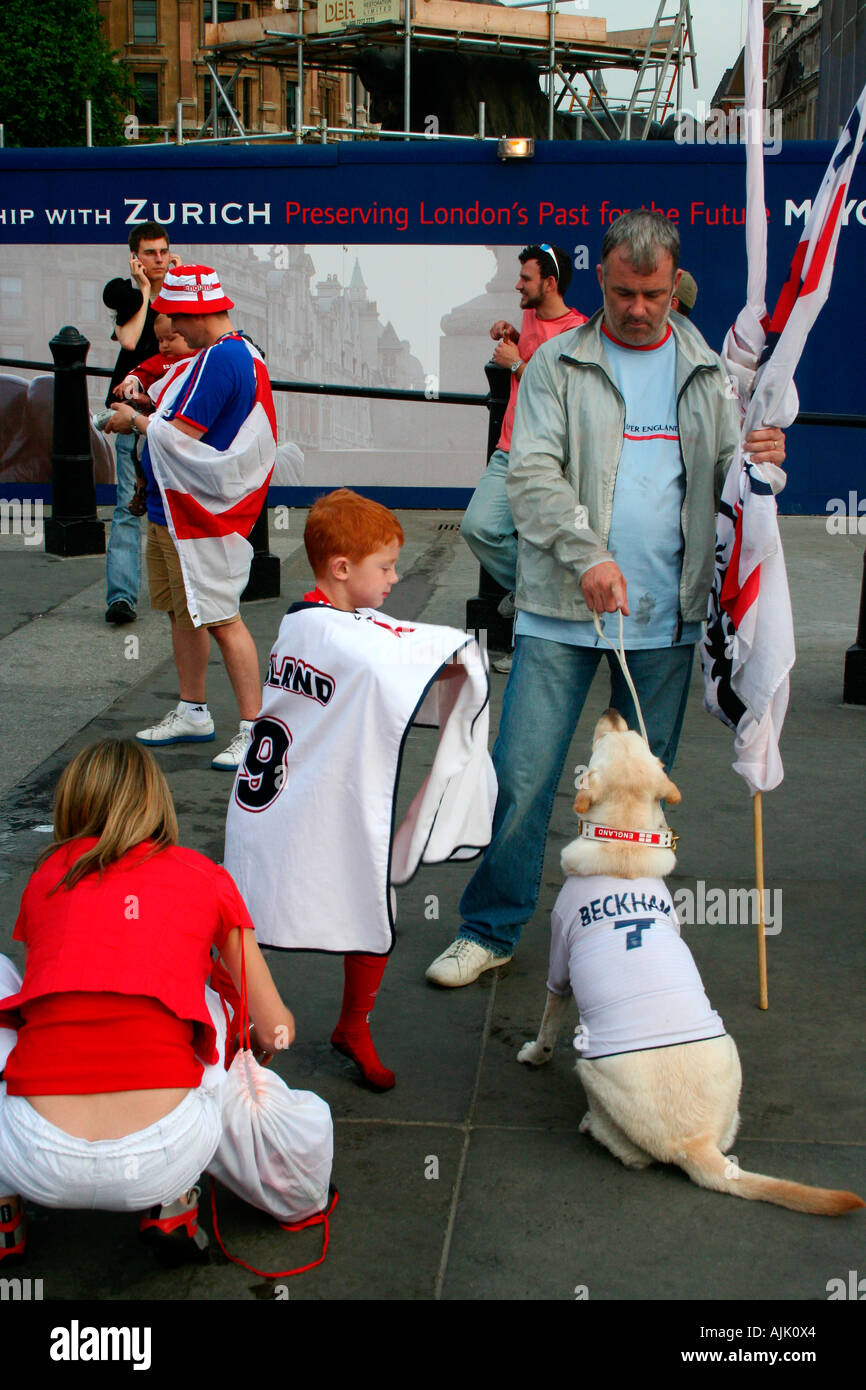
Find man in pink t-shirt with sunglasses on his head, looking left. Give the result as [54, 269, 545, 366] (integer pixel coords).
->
[460, 242, 587, 592]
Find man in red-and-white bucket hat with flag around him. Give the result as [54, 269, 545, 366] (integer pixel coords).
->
[106, 265, 277, 771]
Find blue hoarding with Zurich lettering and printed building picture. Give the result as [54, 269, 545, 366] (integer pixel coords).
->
[0, 139, 866, 513]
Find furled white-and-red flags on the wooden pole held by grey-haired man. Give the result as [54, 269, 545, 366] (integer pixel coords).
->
[701, 0, 866, 794]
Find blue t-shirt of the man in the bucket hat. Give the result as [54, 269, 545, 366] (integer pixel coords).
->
[142, 334, 256, 525]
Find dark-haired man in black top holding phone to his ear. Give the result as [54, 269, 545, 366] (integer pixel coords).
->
[103, 222, 181, 624]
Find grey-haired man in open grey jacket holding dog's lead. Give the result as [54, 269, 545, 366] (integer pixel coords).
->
[427, 211, 785, 987]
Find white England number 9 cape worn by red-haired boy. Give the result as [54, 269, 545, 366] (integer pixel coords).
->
[219, 603, 496, 955]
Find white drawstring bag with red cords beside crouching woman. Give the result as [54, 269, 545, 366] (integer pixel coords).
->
[207, 937, 334, 1222]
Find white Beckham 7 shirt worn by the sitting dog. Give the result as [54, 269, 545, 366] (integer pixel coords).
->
[548, 874, 724, 1059]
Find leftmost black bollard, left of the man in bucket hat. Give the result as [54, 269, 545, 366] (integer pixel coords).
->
[44, 327, 106, 556]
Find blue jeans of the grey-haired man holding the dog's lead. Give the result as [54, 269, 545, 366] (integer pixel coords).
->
[459, 637, 695, 955]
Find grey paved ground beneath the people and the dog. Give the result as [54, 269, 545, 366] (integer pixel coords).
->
[0, 513, 866, 1316]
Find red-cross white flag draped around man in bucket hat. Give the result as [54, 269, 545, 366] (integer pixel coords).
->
[147, 338, 277, 627]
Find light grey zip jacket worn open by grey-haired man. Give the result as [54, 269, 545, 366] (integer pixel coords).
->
[506, 310, 740, 623]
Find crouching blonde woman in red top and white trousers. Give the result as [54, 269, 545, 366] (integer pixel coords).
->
[0, 739, 295, 1268]
